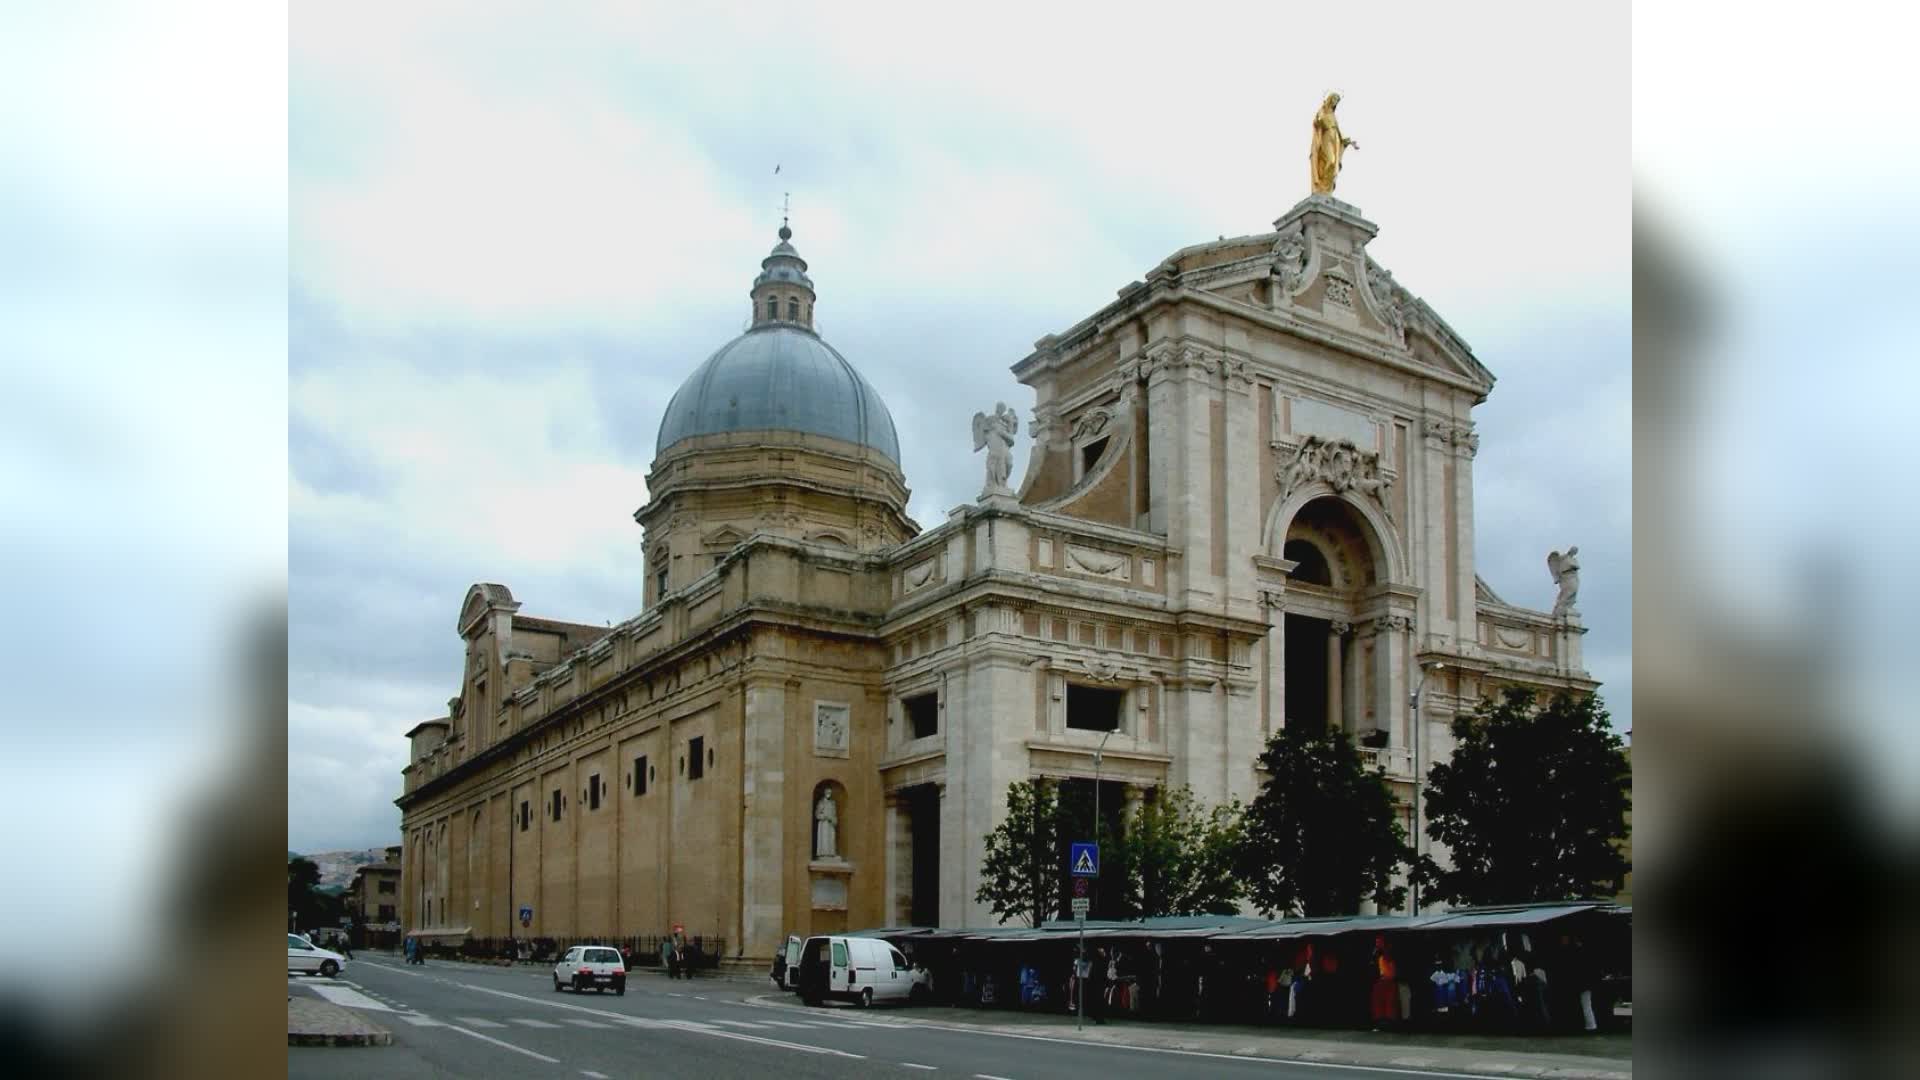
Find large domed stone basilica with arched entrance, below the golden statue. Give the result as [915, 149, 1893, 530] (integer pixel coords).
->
[397, 189, 1596, 957]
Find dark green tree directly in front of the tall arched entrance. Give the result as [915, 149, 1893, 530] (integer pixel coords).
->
[1235, 724, 1413, 915]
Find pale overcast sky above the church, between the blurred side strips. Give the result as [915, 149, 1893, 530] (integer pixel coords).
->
[288, 2, 1632, 851]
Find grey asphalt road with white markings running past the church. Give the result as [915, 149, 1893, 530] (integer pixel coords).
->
[286, 959, 1505, 1080]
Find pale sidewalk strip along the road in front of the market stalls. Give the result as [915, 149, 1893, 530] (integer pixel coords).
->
[753, 994, 1634, 1080]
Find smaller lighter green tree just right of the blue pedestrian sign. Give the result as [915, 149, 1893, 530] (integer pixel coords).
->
[1117, 788, 1246, 917]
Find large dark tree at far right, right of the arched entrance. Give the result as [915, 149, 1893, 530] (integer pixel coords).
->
[1423, 688, 1632, 903]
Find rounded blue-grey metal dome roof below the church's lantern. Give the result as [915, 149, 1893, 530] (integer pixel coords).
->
[655, 323, 900, 465]
